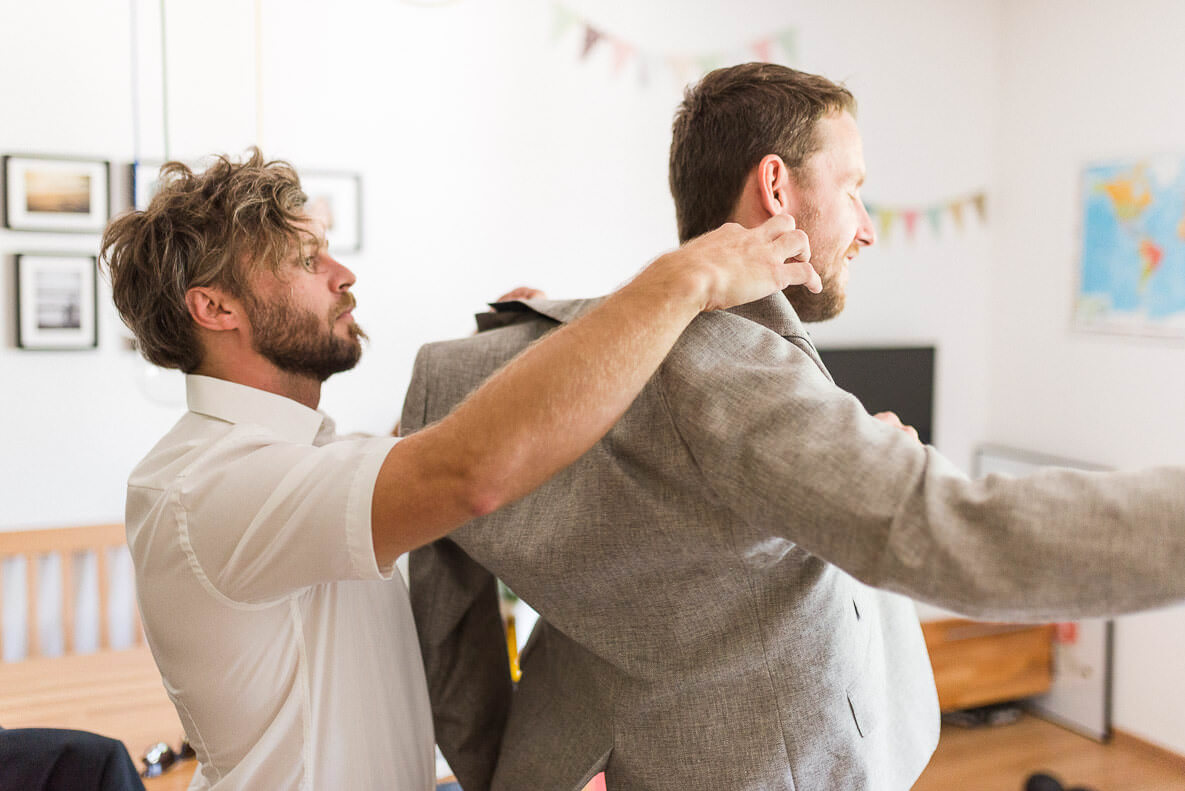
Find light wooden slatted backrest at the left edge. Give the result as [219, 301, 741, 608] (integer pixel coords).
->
[0, 525, 145, 658]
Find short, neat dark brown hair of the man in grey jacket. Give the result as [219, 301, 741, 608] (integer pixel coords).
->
[670, 63, 856, 242]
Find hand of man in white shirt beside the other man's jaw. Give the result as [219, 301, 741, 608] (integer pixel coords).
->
[642, 214, 822, 310]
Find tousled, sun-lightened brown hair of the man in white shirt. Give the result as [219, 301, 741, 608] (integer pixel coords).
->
[101, 148, 306, 373]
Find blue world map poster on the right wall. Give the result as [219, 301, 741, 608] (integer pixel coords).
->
[1075, 156, 1185, 336]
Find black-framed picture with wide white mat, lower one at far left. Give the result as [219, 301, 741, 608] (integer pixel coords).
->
[17, 255, 98, 349]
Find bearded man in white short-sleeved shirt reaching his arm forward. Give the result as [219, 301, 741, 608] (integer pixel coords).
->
[103, 150, 821, 791]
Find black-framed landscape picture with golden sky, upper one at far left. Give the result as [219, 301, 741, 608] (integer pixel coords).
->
[4, 155, 110, 233]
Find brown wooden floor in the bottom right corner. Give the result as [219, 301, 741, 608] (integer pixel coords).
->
[914, 715, 1185, 791]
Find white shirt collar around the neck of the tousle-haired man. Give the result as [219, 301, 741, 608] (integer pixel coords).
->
[185, 373, 327, 444]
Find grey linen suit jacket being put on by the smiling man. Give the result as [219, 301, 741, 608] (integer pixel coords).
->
[402, 294, 1185, 791]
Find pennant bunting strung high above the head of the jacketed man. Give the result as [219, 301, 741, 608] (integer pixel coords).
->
[551, 2, 798, 85]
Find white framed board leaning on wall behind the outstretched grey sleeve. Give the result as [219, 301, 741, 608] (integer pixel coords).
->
[975, 445, 1115, 741]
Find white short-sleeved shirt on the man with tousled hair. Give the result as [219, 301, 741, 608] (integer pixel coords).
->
[127, 375, 435, 791]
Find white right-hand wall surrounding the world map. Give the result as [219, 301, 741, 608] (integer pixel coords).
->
[988, 0, 1185, 752]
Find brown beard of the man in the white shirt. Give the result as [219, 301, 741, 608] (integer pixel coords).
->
[245, 294, 366, 381]
